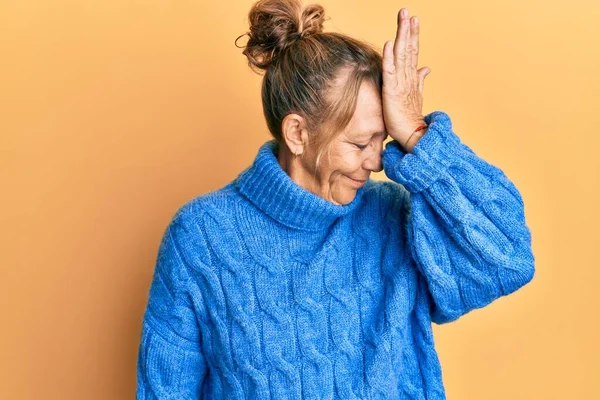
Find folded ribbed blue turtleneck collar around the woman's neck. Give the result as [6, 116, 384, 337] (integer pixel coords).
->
[235, 139, 369, 230]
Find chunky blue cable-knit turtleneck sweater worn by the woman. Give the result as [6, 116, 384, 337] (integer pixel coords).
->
[137, 111, 534, 400]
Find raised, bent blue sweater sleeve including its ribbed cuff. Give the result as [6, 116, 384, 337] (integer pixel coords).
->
[382, 111, 534, 324]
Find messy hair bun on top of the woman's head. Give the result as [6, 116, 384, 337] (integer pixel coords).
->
[236, 0, 325, 70]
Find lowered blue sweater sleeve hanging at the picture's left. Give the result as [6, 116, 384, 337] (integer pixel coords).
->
[136, 213, 207, 400]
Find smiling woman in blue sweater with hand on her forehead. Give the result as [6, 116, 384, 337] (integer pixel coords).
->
[137, 0, 534, 399]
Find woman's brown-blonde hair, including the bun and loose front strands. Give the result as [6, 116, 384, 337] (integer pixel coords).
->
[236, 0, 383, 169]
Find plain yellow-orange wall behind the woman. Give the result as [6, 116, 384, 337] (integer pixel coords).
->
[0, 0, 600, 400]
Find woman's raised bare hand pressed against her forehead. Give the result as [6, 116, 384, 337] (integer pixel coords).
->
[382, 8, 431, 151]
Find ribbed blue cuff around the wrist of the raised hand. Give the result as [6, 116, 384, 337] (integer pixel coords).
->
[382, 111, 462, 193]
